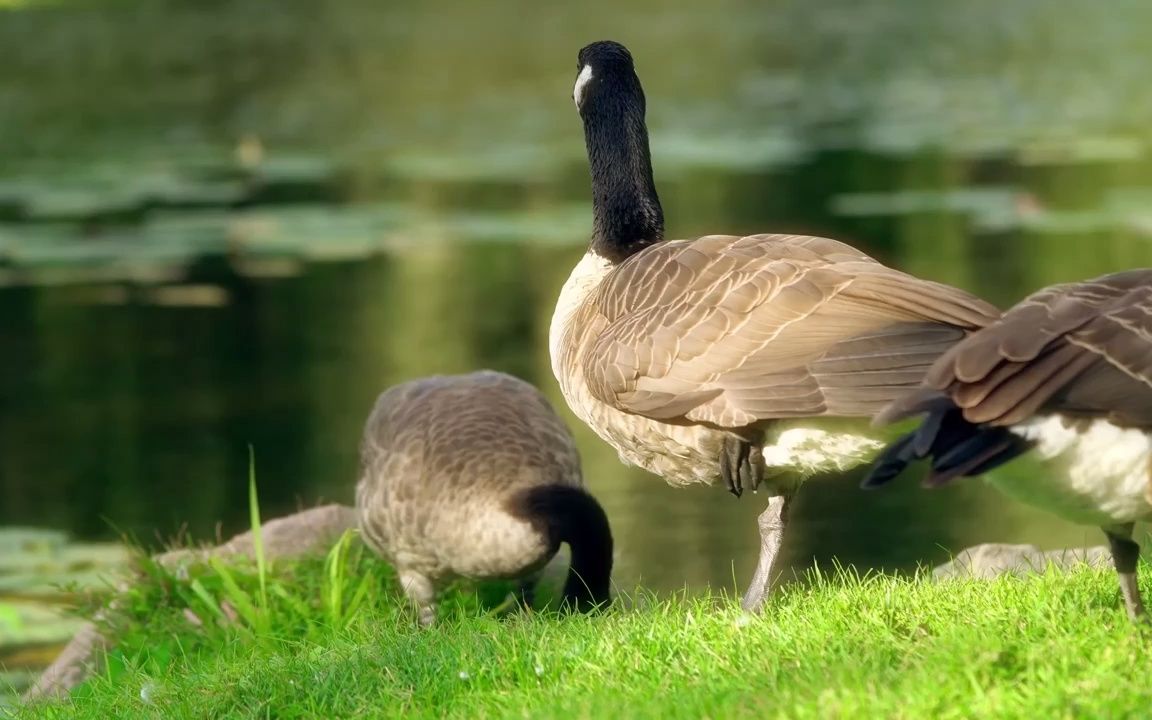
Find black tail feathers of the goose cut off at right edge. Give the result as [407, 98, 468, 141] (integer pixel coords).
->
[861, 394, 1032, 488]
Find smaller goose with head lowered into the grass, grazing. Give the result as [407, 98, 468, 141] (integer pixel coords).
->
[356, 371, 612, 626]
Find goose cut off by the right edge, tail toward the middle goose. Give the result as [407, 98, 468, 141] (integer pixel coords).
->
[864, 270, 1152, 619]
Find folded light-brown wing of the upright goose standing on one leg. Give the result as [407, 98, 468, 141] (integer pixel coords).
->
[584, 235, 999, 427]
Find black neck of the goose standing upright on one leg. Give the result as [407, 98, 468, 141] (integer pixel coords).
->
[581, 75, 664, 263]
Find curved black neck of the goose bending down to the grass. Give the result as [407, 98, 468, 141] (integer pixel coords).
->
[511, 485, 613, 612]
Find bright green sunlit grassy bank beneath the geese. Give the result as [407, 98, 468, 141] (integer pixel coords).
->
[4, 539, 1152, 719]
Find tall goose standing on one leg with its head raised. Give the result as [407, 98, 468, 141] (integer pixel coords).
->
[550, 41, 999, 609]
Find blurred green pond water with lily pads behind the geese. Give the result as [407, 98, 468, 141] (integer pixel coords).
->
[0, 0, 1152, 686]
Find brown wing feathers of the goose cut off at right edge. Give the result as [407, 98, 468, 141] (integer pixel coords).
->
[877, 270, 1152, 426]
